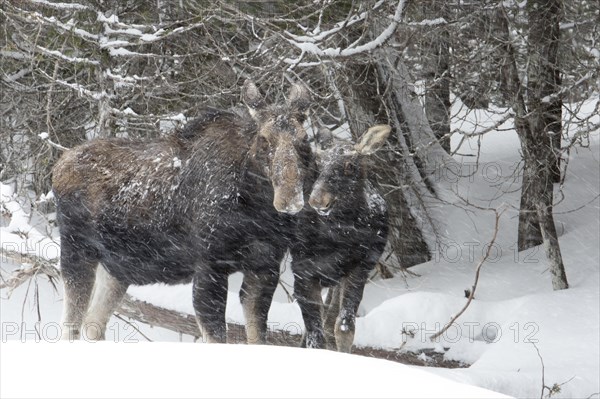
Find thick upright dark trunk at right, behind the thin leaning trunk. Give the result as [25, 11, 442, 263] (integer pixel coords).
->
[518, 0, 561, 250]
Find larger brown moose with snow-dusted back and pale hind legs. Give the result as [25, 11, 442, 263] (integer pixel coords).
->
[53, 82, 313, 343]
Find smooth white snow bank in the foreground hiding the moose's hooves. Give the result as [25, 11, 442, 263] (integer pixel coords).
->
[0, 342, 506, 398]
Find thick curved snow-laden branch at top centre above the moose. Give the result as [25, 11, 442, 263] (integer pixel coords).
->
[284, 0, 405, 64]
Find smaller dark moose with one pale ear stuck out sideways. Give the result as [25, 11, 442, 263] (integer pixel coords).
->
[290, 125, 391, 352]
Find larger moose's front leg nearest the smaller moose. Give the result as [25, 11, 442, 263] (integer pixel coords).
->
[240, 270, 279, 344]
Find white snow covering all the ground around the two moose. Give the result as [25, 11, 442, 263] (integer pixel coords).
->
[0, 98, 600, 398]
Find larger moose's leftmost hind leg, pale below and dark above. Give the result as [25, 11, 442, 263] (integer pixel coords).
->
[60, 244, 98, 341]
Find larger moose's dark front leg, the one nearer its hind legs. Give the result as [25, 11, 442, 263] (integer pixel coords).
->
[192, 269, 227, 343]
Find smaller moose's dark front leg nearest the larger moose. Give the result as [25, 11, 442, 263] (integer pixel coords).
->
[294, 276, 325, 348]
